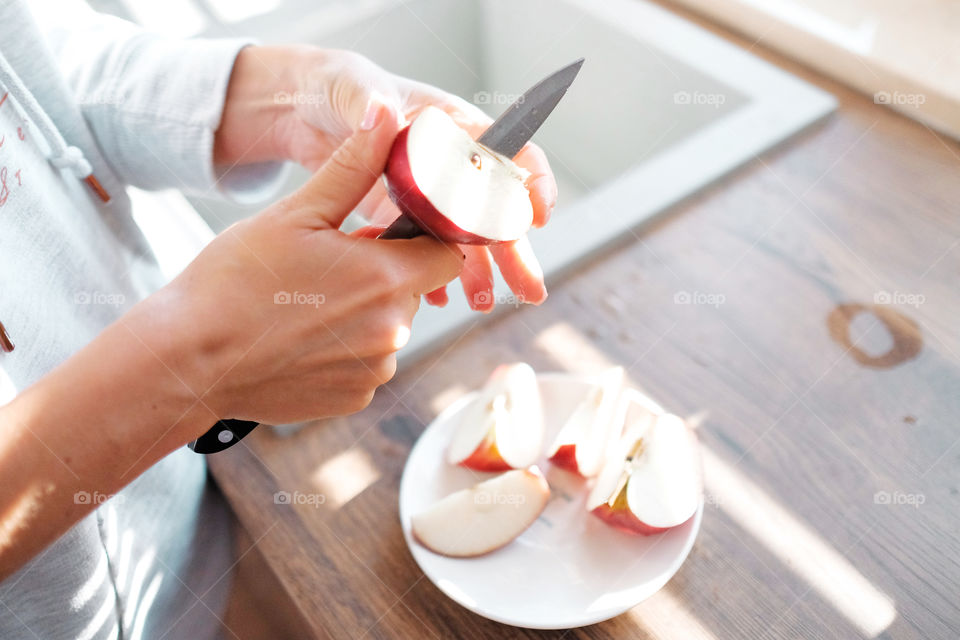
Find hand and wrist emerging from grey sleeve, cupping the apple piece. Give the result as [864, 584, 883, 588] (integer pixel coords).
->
[210, 47, 557, 311]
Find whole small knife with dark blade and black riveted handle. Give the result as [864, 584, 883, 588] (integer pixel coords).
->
[187, 58, 583, 454]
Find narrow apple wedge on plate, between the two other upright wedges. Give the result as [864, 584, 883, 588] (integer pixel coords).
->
[549, 367, 623, 478]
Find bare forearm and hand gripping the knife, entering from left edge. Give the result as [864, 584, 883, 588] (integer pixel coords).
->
[0, 99, 463, 580]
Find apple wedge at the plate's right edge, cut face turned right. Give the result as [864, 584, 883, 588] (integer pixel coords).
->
[587, 414, 703, 535]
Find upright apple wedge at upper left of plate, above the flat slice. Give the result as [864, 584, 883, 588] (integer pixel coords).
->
[447, 362, 544, 471]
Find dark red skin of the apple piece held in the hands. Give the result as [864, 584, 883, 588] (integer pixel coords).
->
[383, 125, 516, 245]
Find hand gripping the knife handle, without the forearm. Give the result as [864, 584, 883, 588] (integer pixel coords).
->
[135, 102, 463, 430]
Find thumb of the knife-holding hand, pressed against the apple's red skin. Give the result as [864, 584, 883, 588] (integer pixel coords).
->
[284, 95, 399, 229]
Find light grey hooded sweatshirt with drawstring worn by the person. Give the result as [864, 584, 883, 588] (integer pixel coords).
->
[0, 0, 280, 640]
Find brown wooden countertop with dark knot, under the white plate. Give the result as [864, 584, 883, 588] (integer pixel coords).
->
[210, 6, 960, 639]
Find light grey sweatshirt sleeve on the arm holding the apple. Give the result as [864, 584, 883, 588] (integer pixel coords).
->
[35, 0, 286, 203]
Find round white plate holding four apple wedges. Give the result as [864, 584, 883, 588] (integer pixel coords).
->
[400, 373, 703, 629]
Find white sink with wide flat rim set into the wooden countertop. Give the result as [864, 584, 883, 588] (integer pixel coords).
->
[97, 0, 835, 362]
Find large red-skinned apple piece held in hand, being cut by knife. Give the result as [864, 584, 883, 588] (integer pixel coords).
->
[384, 106, 533, 244]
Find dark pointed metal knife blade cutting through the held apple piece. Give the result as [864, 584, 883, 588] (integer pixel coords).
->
[378, 58, 583, 240]
